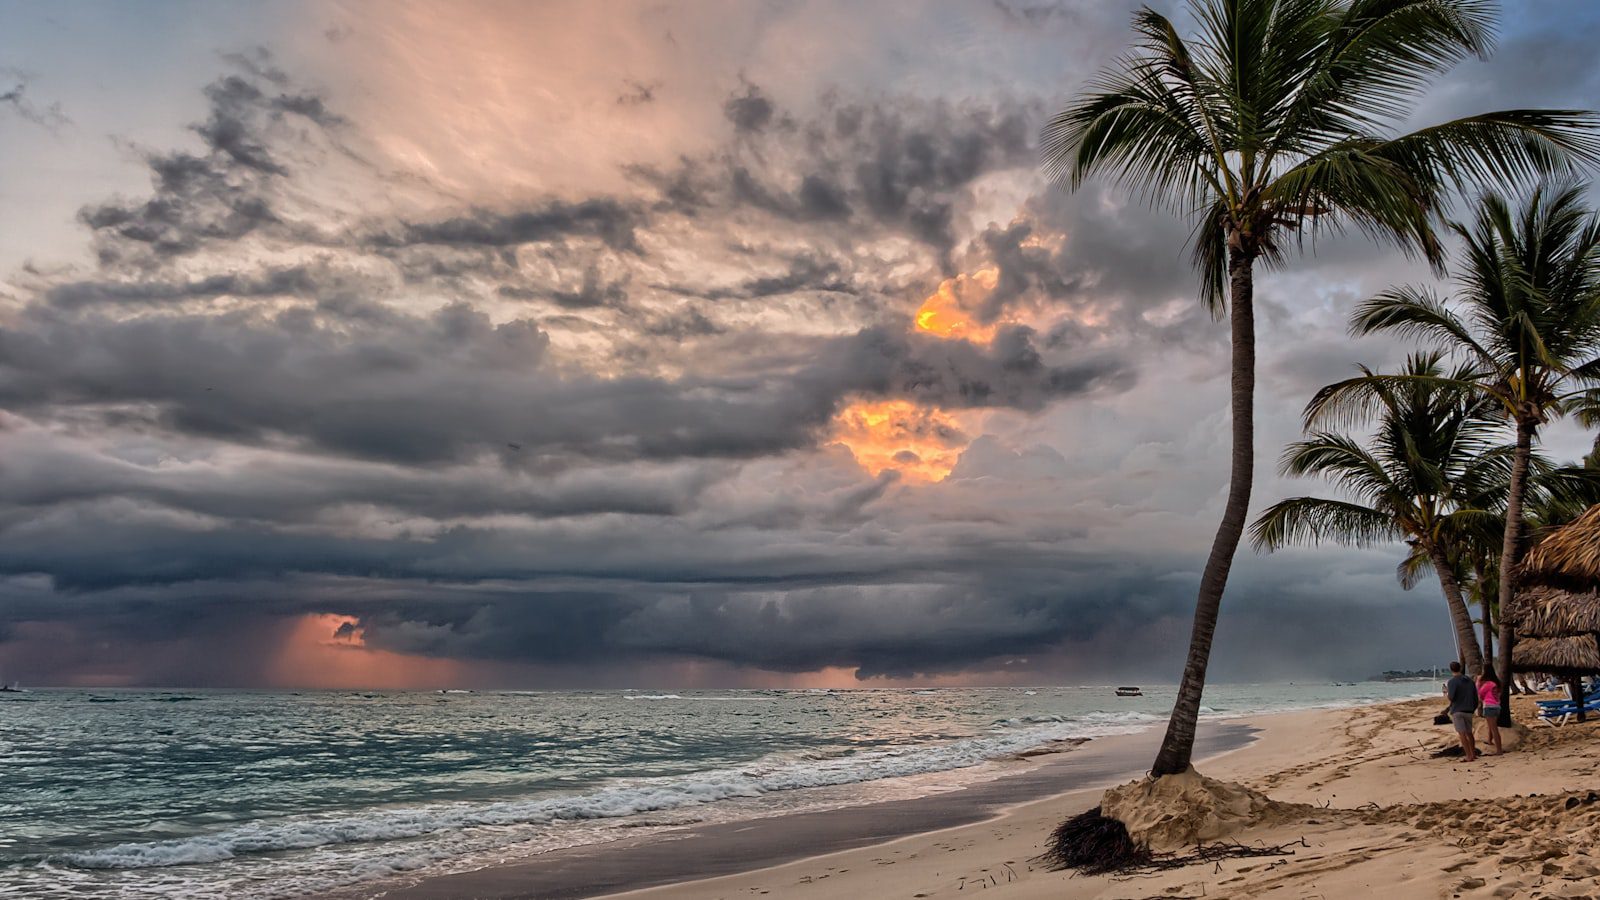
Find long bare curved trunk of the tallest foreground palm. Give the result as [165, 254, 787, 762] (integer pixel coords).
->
[1150, 243, 1256, 777]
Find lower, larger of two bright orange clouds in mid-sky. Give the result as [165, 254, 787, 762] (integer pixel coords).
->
[834, 400, 968, 482]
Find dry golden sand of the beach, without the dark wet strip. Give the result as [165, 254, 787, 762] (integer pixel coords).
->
[604, 698, 1600, 900]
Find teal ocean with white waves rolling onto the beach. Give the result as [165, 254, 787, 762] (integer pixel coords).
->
[0, 682, 1437, 898]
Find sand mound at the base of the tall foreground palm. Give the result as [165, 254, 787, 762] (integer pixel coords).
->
[1101, 769, 1310, 852]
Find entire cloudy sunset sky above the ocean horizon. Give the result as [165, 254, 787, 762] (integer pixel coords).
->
[0, 0, 1600, 689]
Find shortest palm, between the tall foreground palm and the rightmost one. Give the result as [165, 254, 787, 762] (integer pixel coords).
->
[1251, 352, 1506, 674]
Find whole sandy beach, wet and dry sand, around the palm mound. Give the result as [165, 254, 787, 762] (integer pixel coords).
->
[371, 700, 1600, 900]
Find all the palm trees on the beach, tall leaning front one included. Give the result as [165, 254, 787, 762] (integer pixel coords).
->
[1043, 0, 1600, 777]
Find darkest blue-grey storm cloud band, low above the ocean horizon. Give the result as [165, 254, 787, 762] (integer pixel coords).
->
[0, 522, 1448, 677]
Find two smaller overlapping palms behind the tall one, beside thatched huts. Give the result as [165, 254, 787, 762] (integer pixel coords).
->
[1253, 184, 1600, 721]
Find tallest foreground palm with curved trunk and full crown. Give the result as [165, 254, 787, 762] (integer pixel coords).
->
[1043, 0, 1600, 775]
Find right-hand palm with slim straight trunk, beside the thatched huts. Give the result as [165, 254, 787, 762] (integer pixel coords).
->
[1344, 186, 1600, 721]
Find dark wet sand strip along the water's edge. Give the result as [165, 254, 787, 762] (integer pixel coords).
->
[337, 700, 1411, 900]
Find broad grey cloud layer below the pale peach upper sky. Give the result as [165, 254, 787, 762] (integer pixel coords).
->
[12, 3, 1594, 682]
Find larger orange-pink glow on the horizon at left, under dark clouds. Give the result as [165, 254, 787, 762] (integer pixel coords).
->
[264, 613, 462, 690]
